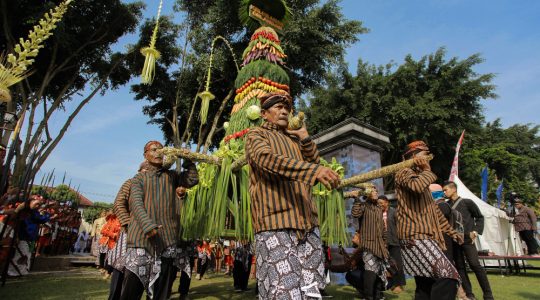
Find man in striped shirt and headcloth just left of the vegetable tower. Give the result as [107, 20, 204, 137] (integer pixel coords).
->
[121, 141, 198, 300]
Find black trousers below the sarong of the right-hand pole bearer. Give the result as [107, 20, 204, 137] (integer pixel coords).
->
[414, 276, 458, 300]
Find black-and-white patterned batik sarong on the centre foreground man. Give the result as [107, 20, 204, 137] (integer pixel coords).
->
[255, 228, 326, 300]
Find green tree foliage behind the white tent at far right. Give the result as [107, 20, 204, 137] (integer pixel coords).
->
[460, 119, 540, 208]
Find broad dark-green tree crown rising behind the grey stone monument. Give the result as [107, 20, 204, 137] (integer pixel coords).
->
[306, 48, 495, 184]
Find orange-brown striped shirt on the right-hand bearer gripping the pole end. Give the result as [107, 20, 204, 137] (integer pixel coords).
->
[395, 168, 457, 249]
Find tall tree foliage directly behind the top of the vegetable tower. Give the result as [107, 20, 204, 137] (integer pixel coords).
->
[132, 0, 367, 150]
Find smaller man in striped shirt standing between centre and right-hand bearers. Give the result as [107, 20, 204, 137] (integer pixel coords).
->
[351, 185, 388, 300]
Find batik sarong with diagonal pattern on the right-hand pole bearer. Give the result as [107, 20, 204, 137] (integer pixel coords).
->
[399, 240, 460, 280]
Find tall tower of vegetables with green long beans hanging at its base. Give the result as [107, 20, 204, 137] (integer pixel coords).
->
[159, 0, 349, 244]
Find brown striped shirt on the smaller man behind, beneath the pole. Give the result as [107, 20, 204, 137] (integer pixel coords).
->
[351, 199, 388, 259]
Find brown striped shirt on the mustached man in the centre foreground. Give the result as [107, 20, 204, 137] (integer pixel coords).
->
[246, 122, 320, 233]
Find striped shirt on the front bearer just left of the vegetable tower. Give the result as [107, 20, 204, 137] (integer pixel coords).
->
[127, 164, 198, 254]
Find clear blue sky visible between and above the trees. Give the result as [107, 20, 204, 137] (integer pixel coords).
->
[37, 0, 540, 202]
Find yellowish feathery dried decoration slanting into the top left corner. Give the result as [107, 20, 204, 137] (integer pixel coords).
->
[0, 0, 72, 102]
